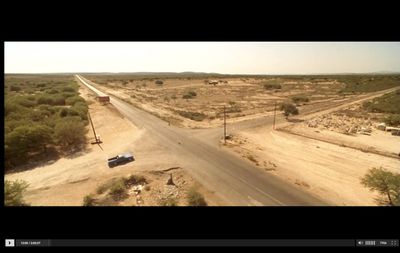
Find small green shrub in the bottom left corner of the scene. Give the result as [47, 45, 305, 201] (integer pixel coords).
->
[4, 180, 29, 206]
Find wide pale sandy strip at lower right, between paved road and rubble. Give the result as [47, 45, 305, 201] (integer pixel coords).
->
[228, 128, 400, 206]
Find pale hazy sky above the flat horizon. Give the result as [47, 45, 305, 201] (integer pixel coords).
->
[4, 42, 400, 74]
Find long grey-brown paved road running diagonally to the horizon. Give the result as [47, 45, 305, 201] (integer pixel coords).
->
[76, 75, 328, 206]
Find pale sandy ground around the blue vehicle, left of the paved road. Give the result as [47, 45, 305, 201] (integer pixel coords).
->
[5, 84, 219, 206]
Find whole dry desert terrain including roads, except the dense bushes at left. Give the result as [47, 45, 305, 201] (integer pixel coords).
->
[5, 73, 400, 206]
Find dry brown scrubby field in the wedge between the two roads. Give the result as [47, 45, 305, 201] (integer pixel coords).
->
[83, 76, 351, 128]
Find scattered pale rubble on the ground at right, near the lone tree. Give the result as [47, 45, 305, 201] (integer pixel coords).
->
[305, 114, 374, 135]
